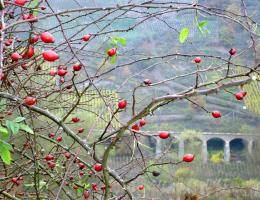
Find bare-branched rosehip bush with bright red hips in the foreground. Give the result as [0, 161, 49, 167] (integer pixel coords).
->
[0, 0, 260, 199]
